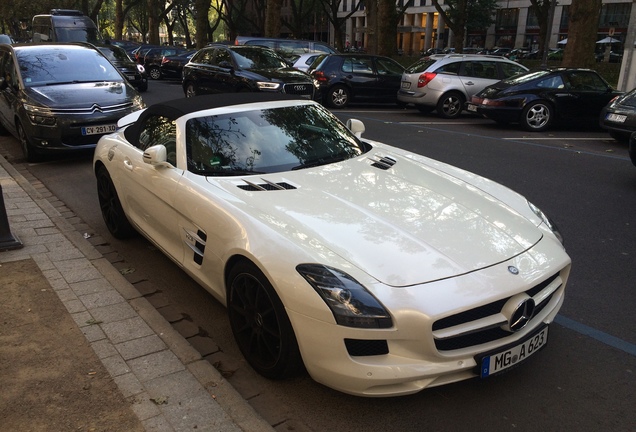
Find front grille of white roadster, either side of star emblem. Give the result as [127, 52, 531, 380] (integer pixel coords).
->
[433, 273, 561, 351]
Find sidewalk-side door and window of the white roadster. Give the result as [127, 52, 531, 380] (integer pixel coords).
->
[115, 115, 183, 262]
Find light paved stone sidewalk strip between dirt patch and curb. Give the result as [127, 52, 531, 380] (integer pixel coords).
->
[0, 156, 273, 432]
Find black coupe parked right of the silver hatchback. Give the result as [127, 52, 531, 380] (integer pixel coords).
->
[466, 68, 621, 132]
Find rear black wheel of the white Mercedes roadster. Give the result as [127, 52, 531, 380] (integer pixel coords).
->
[96, 166, 136, 239]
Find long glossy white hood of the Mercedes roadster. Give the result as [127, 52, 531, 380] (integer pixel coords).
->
[208, 150, 542, 286]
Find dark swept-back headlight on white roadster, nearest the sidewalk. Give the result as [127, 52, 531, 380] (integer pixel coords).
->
[296, 264, 393, 328]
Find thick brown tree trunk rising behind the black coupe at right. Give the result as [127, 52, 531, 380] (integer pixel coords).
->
[561, 0, 602, 68]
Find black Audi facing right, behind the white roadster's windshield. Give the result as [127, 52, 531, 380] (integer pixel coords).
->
[183, 45, 314, 99]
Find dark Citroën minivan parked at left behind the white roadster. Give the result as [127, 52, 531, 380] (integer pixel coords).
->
[0, 43, 144, 161]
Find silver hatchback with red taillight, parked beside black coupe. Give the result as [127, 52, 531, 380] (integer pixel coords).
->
[398, 54, 528, 118]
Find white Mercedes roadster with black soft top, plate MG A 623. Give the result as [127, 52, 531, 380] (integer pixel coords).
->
[94, 93, 571, 396]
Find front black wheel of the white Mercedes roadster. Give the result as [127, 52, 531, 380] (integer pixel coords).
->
[227, 260, 302, 379]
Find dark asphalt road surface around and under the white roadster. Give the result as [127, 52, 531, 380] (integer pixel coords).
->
[0, 81, 636, 431]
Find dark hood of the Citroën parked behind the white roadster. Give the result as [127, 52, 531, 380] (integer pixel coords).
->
[25, 81, 137, 108]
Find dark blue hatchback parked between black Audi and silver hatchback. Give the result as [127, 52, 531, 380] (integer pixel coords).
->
[311, 54, 404, 108]
